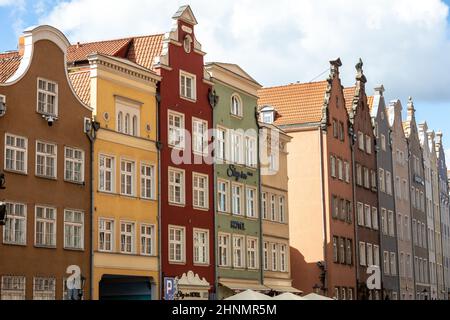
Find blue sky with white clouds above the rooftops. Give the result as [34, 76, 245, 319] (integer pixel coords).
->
[0, 0, 450, 163]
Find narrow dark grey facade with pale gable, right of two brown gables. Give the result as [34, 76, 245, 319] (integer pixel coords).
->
[371, 86, 400, 300]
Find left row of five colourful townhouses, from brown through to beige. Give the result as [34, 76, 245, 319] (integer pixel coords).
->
[0, 6, 300, 300]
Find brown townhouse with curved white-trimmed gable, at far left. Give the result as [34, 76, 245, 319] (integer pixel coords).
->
[0, 26, 92, 300]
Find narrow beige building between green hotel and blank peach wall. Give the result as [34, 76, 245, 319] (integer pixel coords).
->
[260, 120, 301, 293]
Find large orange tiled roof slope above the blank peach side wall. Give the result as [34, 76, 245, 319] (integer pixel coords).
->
[258, 81, 328, 126]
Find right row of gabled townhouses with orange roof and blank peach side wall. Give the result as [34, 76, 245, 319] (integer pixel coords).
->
[258, 59, 450, 300]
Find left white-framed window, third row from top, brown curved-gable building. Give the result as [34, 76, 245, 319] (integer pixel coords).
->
[3, 202, 27, 245]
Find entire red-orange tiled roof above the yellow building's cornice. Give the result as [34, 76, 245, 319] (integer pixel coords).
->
[67, 34, 164, 70]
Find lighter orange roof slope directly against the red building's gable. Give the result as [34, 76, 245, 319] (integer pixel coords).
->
[127, 34, 164, 70]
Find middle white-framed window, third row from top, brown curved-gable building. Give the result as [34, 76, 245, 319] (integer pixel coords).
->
[35, 207, 56, 247]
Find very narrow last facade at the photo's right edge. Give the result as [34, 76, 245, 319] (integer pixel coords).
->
[436, 132, 450, 300]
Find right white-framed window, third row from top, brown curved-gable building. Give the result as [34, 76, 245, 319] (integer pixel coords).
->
[64, 210, 84, 250]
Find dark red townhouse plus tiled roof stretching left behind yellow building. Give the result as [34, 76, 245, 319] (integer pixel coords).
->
[67, 6, 215, 299]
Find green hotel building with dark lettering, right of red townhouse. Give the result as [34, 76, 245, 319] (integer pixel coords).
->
[206, 62, 267, 299]
